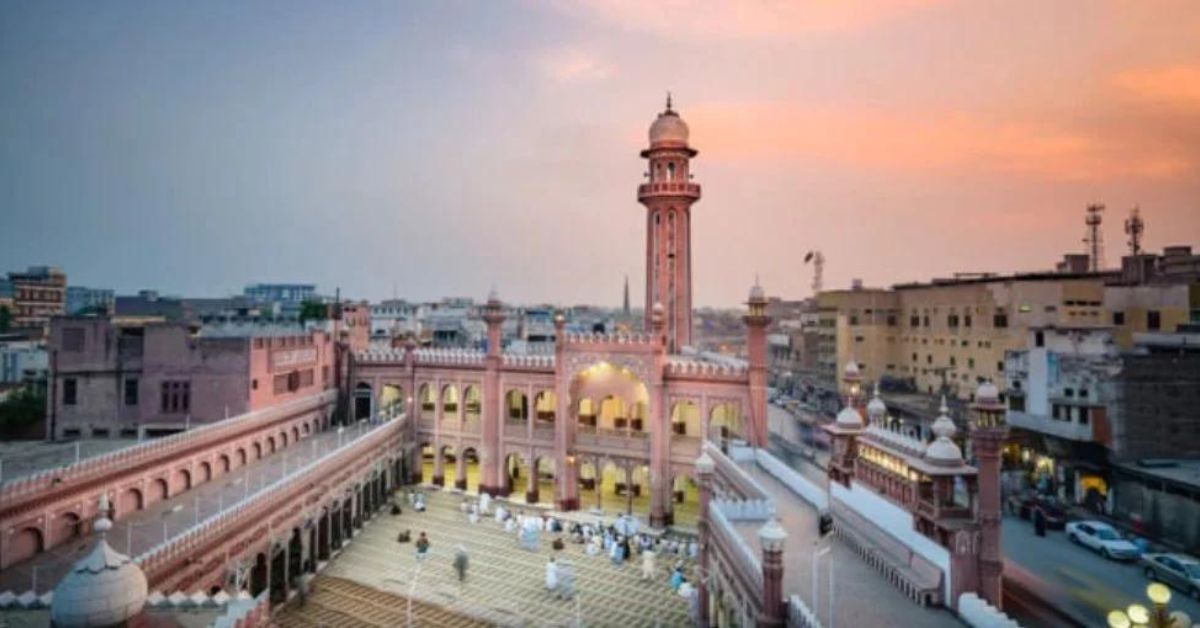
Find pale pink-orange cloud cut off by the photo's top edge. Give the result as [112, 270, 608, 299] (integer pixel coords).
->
[565, 0, 936, 38]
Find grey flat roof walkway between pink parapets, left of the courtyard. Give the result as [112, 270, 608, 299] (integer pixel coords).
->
[0, 424, 384, 594]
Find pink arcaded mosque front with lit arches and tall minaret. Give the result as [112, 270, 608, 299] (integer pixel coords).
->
[344, 97, 769, 526]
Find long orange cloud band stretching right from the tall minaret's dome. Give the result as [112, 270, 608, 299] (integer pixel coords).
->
[684, 103, 1196, 180]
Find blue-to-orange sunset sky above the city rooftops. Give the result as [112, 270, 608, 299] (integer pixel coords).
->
[0, 0, 1200, 306]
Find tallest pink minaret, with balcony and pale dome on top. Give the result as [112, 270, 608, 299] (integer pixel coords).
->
[637, 94, 700, 353]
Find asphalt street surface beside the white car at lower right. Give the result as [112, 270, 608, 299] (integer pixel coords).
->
[1001, 518, 1200, 626]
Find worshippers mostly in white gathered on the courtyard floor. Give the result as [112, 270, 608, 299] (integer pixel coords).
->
[392, 490, 700, 612]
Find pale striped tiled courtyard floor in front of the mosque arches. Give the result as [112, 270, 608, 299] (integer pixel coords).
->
[295, 491, 688, 628]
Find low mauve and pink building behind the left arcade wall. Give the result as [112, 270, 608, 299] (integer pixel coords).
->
[47, 317, 334, 438]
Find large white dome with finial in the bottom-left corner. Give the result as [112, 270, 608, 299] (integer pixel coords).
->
[50, 496, 149, 628]
